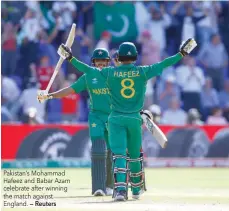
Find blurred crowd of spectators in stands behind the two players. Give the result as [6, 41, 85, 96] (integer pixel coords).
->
[1, 1, 229, 125]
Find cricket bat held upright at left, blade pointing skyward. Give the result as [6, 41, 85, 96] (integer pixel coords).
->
[45, 23, 76, 93]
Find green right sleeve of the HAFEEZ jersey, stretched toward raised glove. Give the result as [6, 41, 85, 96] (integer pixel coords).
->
[142, 53, 183, 80]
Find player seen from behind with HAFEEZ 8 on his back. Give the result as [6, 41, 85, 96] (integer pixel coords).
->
[60, 39, 197, 201]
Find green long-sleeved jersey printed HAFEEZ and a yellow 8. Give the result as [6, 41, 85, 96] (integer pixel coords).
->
[71, 53, 182, 113]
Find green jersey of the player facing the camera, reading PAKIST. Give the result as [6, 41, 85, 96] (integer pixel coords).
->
[71, 57, 111, 114]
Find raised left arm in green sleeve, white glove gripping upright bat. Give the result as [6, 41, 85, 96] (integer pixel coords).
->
[57, 44, 92, 73]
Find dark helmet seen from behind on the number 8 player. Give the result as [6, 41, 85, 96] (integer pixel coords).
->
[118, 42, 138, 61]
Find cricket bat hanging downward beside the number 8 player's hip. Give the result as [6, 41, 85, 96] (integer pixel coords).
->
[141, 114, 168, 148]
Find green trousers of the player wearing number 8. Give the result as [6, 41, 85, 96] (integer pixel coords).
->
[108, 112, 142, 193]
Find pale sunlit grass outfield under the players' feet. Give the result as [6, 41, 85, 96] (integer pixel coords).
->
[2, 168, 229, 211]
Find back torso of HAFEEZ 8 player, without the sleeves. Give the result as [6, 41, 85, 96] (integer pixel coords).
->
[107, 64, 147, 113]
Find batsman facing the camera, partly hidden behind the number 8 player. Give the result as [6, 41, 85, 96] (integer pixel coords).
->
[38, 48, 113, 196]
